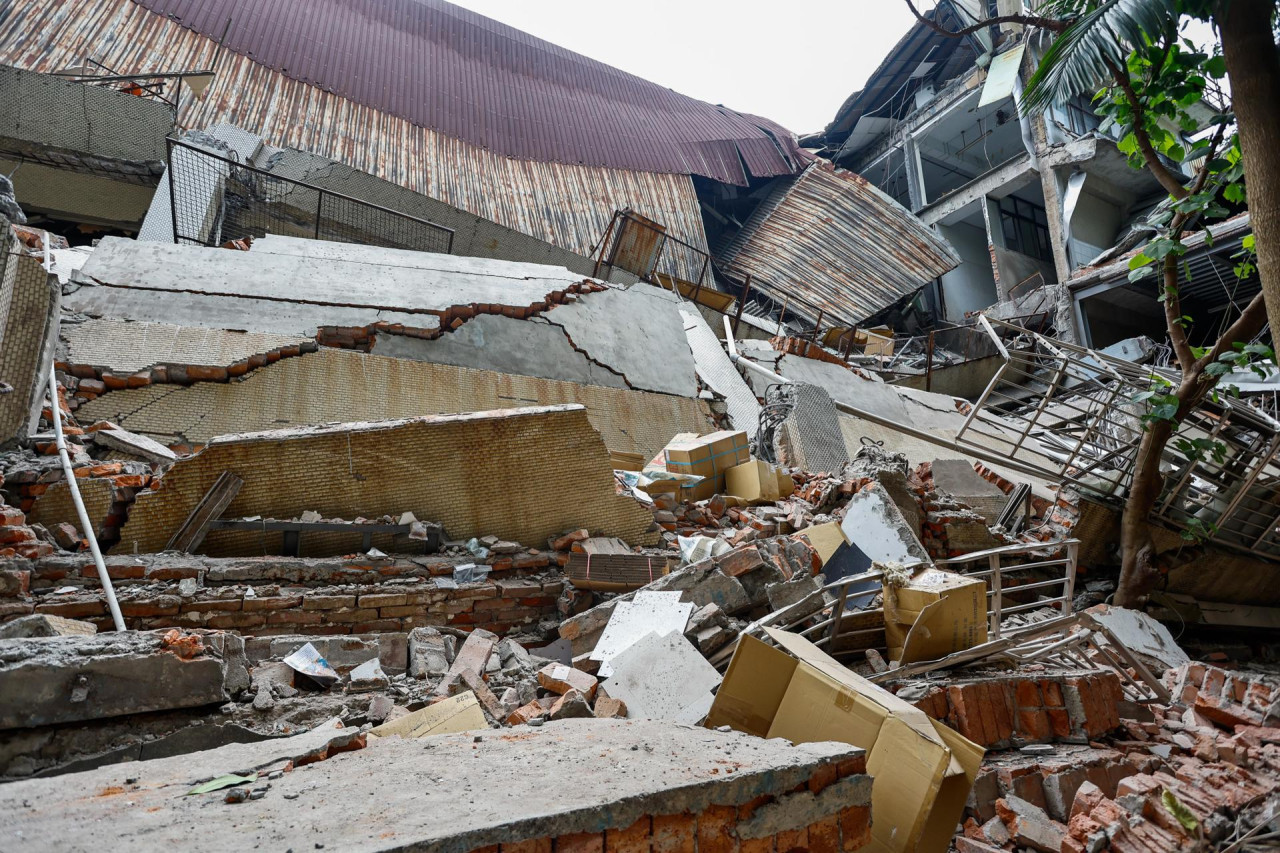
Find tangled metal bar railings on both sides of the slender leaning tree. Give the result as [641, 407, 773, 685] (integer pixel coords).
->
[956, 318, 1280, 560]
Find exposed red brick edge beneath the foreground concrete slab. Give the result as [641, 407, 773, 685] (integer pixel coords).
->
[474, 757, 872, 853]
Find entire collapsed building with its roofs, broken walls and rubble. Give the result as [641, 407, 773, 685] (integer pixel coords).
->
[0, 0, 1280, 853]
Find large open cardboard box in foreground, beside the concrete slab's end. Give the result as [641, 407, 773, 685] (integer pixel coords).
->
[705, 628, 984, 853]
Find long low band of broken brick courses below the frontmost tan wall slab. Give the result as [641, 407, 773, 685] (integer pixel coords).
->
[0, 550, 566, 637]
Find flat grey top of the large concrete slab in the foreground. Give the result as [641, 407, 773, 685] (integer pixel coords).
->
[0, 720, 870, 853]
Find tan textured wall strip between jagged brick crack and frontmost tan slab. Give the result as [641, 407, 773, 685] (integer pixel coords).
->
[76, 345, 714, 459]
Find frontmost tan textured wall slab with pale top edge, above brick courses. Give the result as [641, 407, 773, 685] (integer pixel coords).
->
[113, 406, 657, 556]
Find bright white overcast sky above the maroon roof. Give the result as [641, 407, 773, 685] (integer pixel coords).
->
[453, 0, 933, 133]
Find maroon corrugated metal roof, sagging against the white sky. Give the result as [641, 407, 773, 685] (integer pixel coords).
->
[120, 0, 809, 184]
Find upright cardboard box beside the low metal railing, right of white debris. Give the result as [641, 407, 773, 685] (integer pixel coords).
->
[884, 569, 987, 663]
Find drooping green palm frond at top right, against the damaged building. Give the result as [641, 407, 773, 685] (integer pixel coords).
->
[1021, 0, 1178, 113]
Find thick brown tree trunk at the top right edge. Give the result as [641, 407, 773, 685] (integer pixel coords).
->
[1213, 0, 1280, 336]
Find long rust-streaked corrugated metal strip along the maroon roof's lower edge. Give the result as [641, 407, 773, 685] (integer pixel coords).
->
[0, 0, 716, 266]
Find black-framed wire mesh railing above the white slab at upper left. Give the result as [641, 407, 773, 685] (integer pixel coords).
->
[168, 138, 453, 254]
